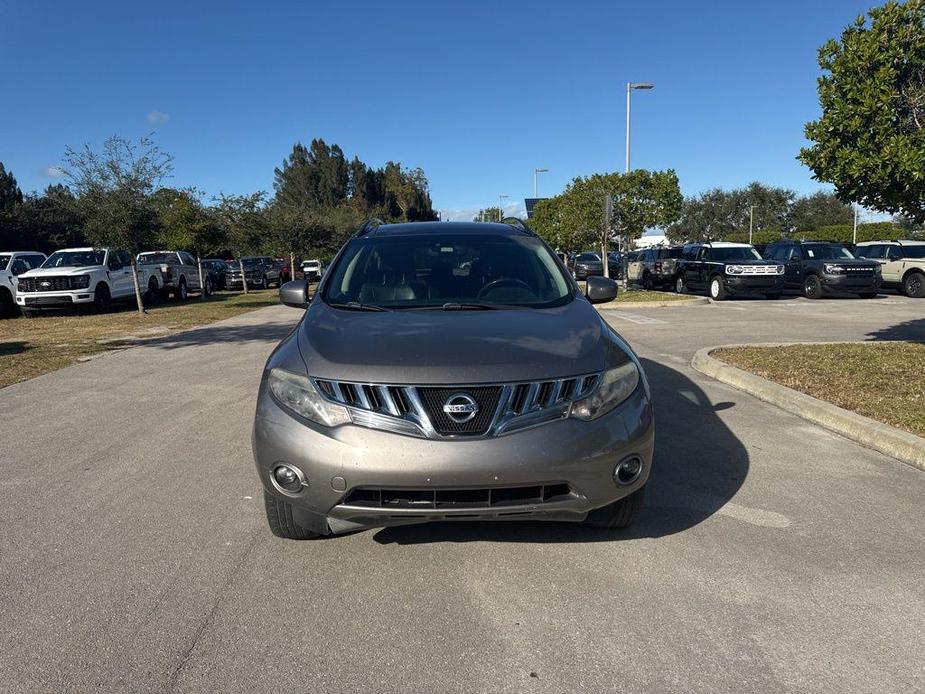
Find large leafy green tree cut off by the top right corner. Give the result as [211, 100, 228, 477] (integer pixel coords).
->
[799, 0, 925, 222]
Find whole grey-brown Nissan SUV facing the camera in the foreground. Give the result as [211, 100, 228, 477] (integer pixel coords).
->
[253, 220, 655, 539]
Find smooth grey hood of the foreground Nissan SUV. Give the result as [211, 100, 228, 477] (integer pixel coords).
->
[298, 298, 612, 385]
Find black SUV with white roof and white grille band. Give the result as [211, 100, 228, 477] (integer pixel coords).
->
[675, 241, 784, 301]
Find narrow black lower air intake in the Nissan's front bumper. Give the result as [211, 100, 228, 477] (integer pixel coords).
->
[343, 483, 572, 509]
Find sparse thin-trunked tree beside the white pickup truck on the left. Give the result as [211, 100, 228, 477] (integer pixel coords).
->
[64, 135, 173, 313]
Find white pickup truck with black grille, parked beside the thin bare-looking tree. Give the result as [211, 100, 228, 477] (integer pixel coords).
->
[16, 248, 159, 316]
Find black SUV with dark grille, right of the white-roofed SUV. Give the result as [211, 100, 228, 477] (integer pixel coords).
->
[764, 239, 883, 299]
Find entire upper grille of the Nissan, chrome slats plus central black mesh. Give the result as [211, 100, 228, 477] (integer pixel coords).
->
[315, 374, 600, 439]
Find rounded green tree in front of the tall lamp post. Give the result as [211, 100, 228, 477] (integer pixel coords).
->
[558, 169, 683, 273]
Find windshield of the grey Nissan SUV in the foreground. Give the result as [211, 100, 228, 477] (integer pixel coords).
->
[322, 234, 571, 308]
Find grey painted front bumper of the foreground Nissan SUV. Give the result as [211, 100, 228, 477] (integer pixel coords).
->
[252, 384, 655, 534]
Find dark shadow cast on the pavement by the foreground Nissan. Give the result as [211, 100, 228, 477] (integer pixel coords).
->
[373, 359, 749, 545]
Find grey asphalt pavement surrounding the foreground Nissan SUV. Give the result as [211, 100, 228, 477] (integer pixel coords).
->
[0, 296, 925, 692]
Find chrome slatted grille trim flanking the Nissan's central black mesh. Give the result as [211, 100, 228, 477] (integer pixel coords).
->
[313, 373, 600, 439]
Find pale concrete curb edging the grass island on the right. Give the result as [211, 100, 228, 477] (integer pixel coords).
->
[691, 342, 925, 470]
